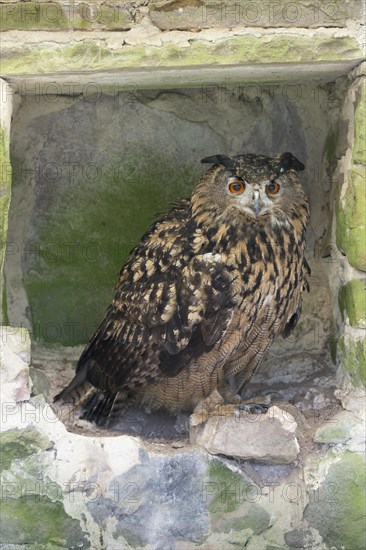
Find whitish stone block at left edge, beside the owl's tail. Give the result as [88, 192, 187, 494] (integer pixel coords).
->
[0, 326, 31, 404]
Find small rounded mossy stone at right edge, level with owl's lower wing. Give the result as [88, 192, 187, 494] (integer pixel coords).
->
[338, 279, 366, 328]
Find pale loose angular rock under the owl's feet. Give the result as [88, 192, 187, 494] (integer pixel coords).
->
[190, 407, 300, 464]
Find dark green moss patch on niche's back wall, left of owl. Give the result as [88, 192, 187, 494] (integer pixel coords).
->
[24, 154, 197, 345]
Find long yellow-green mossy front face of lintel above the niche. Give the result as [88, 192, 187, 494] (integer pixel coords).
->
[2, 34, 363, 75]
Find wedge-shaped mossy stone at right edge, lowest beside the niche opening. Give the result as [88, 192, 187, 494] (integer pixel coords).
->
[337, 336, 366, 386]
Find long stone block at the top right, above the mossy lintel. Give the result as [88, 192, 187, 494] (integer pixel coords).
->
[149, 0, 362, 31]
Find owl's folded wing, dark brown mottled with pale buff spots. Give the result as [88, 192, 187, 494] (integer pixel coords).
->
[59, 205, 233, 404]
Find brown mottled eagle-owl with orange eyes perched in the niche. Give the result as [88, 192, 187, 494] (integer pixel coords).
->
[55, 153, 310, 430]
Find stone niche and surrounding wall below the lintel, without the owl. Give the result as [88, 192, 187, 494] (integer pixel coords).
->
[0, 59, 366, 550]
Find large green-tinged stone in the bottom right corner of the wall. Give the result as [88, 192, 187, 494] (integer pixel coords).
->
[304, 452, 366, 550]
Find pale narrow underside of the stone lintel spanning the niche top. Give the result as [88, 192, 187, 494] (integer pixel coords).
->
[7, 61, 359, 93]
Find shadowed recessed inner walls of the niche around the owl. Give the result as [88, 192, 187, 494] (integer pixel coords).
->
[5, 78, 344, 438]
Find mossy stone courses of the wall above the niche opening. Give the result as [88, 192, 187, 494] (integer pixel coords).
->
[0, 0, 364, 77]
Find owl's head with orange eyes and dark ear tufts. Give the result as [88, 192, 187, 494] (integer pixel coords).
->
[192, 153, 308, 227]
